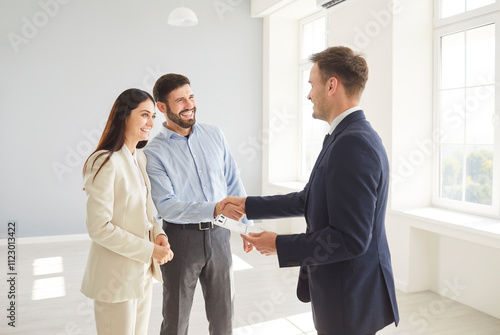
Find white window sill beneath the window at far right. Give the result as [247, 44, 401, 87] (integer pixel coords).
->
[388, 207, 500, 249]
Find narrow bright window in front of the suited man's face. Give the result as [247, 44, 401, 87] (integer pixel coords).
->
[298, 13, 328, 181]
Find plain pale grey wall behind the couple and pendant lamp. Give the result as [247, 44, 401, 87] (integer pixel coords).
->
[0, 0, 262, 237]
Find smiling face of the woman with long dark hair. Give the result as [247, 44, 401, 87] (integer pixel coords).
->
[125, 99, 156, 152]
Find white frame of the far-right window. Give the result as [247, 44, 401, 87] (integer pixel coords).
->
[431, 0, 500, 218]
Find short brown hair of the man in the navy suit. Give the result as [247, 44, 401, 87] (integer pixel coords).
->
[310, 46, 368, 97]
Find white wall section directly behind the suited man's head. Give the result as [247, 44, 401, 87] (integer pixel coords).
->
[328, 0, 393, 151]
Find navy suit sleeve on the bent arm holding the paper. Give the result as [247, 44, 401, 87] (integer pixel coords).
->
[276, 136, 382, 267]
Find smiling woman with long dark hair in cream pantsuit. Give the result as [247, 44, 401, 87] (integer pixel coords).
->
[81, 89, 173, 335]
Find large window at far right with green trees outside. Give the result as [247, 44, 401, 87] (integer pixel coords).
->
[433, 0, 500, 215]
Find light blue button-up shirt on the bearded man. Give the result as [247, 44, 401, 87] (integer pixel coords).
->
[144, 123, 253, 225]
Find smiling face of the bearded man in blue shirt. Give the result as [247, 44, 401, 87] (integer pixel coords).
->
[166, 84, 196, 133]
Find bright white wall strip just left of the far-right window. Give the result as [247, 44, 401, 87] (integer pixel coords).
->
[391, 0, 433, 209]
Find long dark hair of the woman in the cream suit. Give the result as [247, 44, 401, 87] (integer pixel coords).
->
[83, 88, 154, 179]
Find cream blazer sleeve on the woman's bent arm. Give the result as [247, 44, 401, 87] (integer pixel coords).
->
[84, 154, 154, 263]
